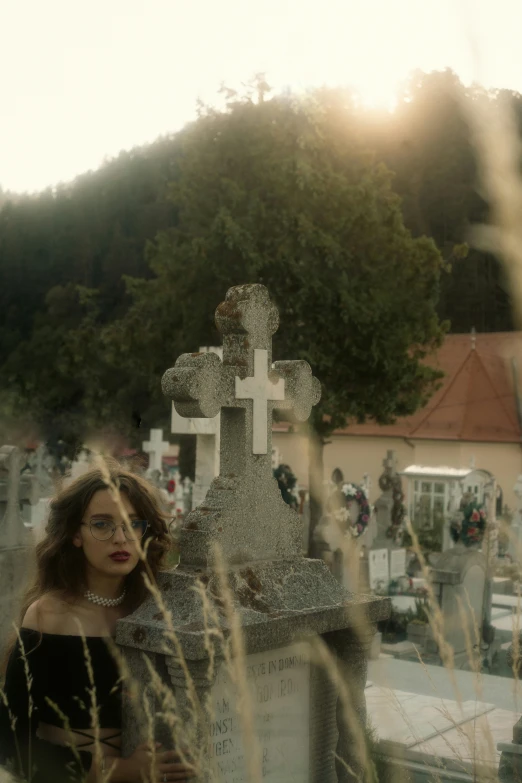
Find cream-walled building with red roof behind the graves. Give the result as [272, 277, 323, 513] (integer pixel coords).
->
[274, 332, 522, 509]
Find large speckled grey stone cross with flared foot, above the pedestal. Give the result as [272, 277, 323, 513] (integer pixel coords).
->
[163, 285, 321, 564]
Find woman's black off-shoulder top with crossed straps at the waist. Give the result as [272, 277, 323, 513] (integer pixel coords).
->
[0, 628, 121, 783]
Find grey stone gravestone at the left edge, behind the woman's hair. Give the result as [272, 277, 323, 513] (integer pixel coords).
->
[0, 446, 38, 656]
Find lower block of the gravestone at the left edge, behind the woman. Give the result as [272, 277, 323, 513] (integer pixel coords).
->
[0, 546, 34, 659]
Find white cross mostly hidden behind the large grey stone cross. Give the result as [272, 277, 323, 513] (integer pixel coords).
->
[171, 346, 223, 508]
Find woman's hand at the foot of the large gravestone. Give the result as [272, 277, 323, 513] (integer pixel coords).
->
[110, 742, 196, 783]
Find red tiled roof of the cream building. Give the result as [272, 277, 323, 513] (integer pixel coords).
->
[339, 332, 522, 443]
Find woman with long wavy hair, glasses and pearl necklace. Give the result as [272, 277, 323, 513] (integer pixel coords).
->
[0, 462, 194, 783]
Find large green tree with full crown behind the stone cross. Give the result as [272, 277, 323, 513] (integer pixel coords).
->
[106, 82, 443, 552]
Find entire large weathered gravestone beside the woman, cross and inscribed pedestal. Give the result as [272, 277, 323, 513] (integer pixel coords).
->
[117, 285, 389, 783]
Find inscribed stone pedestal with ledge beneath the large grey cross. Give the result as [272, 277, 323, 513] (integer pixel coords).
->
[116, 558, 389, 783]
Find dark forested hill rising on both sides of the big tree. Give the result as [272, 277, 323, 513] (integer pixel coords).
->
[0, 71, 512, 454]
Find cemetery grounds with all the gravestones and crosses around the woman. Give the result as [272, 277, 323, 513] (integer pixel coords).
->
[0, 286, 522, 783]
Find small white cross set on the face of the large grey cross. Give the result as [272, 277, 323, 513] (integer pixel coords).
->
[236, 348, 285, 454]
